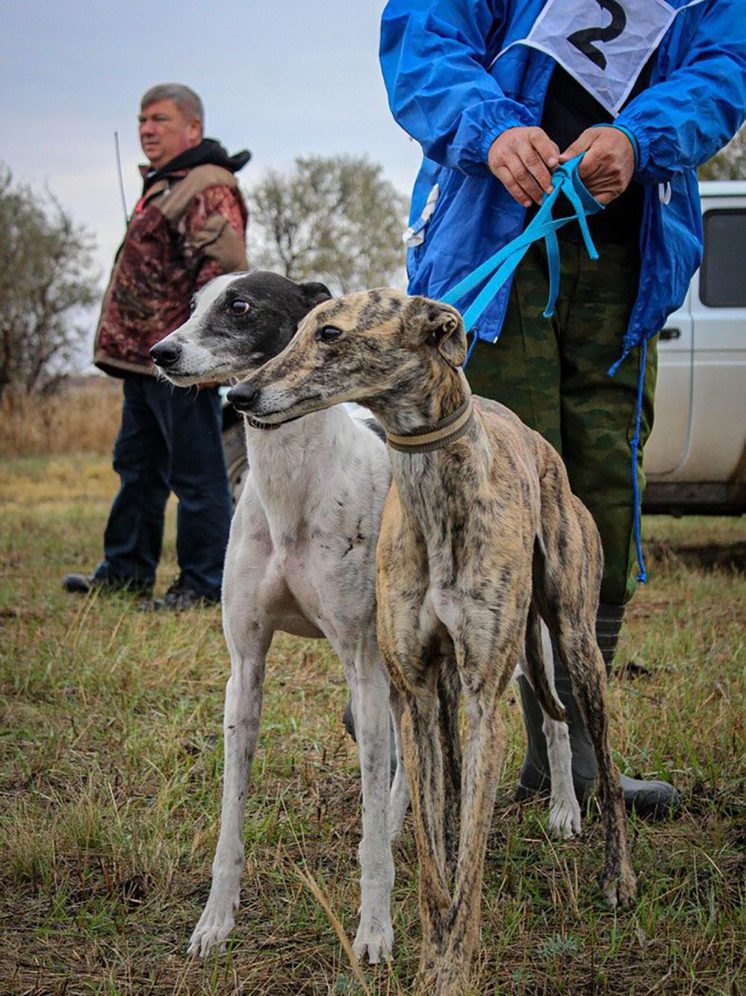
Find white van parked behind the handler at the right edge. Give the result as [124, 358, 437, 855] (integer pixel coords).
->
[643, 180, 746, 515]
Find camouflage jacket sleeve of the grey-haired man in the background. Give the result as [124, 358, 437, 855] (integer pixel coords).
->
[182, 186, 248, 290]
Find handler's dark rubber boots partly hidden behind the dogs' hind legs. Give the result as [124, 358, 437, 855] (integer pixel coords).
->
[515, 604, 680, 819]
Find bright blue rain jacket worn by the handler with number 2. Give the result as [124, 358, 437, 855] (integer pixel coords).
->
[380, 0, 746, 353]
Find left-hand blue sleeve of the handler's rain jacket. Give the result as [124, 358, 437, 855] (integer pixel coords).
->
[380, 0, 533, 173]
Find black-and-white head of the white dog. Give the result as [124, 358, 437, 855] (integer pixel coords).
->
[150, 270, 331, 387]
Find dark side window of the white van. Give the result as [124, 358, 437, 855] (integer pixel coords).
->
[699, 208, 746, 308]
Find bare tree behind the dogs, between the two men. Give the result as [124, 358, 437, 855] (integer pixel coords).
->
[249, 156, 407, 293]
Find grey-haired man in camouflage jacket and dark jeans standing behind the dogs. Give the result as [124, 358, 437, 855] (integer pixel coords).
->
[63, 83, 250, 609]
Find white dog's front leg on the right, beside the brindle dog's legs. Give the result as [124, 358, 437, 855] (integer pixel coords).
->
[350, 636, 394, 965]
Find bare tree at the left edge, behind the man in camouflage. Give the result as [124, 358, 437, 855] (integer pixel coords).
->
[0, 166, 98, 398]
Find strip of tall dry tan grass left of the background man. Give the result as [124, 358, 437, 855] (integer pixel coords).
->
[0, 376, 122, 457]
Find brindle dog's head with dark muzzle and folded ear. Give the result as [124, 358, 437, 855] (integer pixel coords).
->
[228, 290, 466, 424]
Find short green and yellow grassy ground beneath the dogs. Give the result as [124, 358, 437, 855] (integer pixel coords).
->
[0, 455, 746, 996]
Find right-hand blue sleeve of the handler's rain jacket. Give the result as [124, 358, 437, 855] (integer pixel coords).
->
[615, 0, 746, 183]
